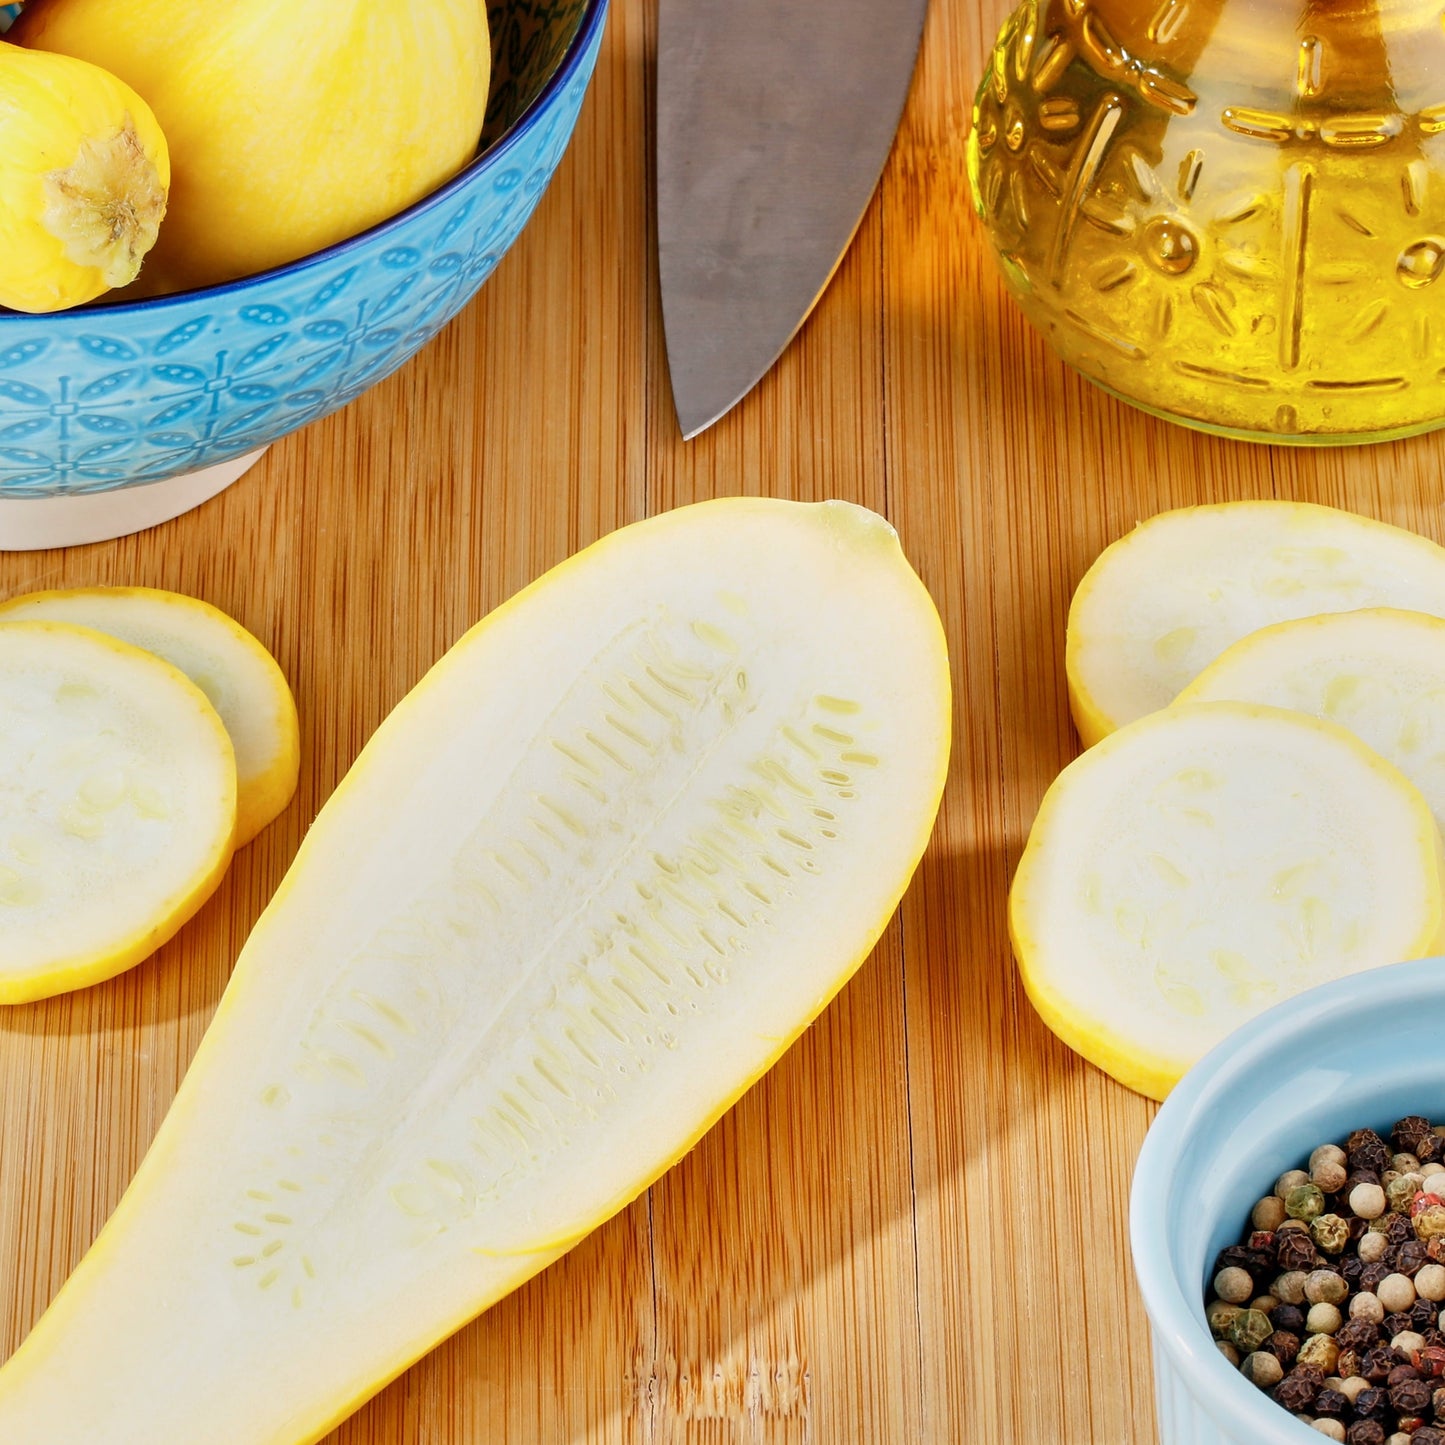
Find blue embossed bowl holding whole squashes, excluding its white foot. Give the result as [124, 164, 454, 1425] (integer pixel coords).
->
[0, 0, 607, 499]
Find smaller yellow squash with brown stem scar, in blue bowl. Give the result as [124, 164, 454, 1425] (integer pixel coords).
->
[0, 40, 171, 312]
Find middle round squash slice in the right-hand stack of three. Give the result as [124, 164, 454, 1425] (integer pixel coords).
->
[1178, 607, 1445, 827]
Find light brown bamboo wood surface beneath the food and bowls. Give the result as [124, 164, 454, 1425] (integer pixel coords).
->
[0, 0, 1445, 1445]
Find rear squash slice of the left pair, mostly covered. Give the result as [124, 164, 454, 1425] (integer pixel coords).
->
[0, 587, 301, 848]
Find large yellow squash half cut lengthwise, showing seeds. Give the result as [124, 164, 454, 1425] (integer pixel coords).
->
[0, 499, 949, 1445]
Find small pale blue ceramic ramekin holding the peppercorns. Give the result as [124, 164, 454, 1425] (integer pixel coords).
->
[1129, 958, 1445, 1445]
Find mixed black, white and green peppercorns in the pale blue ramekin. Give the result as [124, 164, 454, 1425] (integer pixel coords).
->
[1205, 1114, 1445, 1445]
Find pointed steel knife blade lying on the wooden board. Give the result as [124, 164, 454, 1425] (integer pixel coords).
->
[656, 0, 928, 438]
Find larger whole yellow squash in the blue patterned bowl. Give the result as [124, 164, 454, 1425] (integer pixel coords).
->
[10, 0, 491, 292]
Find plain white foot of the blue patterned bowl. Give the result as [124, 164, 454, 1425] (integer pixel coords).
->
[0, 447, 266, 552]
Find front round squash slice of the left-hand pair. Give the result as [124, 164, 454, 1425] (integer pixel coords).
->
[0, 621, 236, 1003]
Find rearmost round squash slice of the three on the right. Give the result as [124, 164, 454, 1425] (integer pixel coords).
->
[1065, 501, 1445, 747]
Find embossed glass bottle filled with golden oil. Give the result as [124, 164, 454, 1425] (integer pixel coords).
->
[968, 0, 1445, 442]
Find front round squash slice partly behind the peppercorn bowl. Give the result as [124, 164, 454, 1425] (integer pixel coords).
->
[1009, 702, 1445, 1098]
